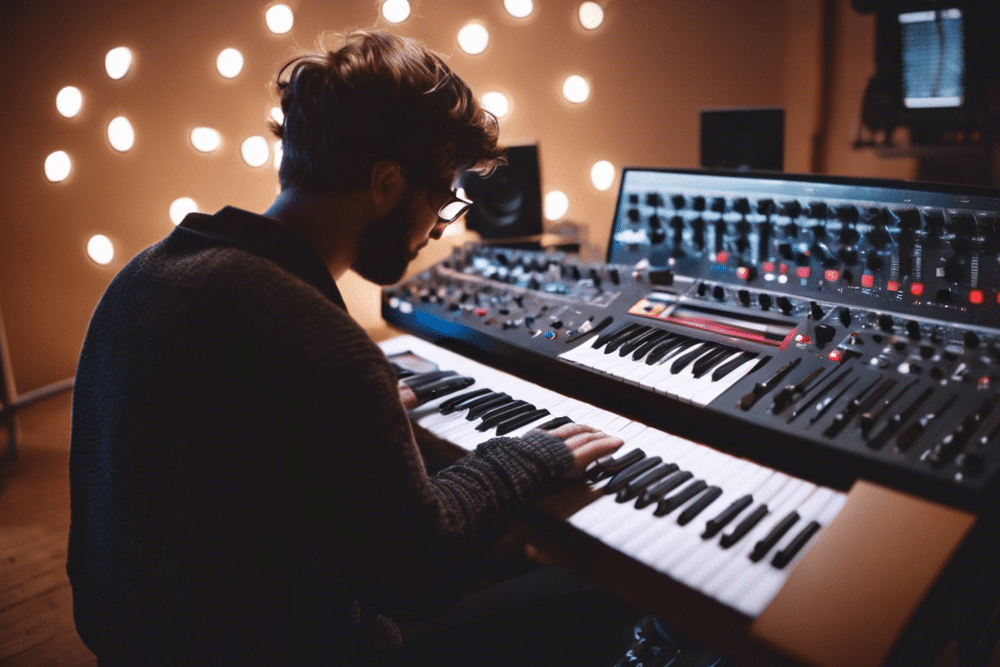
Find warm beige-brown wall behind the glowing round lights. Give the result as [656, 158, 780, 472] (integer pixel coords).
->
[0, 0, 913, 392]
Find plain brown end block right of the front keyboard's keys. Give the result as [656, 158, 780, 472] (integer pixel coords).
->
[751, 481, 975, 667]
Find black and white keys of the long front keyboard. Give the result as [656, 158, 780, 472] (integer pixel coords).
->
[382, 336, 845, 617]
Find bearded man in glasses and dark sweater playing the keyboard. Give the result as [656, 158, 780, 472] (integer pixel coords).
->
[67, 32, 621, 667]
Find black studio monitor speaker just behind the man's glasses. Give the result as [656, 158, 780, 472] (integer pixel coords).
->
[460, 144, 542, 239]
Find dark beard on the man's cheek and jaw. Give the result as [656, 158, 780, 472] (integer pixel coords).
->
[351, 190, 416, 285]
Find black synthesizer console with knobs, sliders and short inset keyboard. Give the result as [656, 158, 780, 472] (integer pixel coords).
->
[382, 168, 1000, 667]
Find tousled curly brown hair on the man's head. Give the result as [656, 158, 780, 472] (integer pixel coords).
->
[271, 30, 504, 192]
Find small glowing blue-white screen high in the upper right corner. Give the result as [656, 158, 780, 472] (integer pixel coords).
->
[899, 9, 965, 109]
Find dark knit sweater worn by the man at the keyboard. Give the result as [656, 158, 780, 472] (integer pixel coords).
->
[67, 208, 572, 665]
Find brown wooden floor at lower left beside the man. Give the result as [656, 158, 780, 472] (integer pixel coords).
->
[0, 392, 97, 667]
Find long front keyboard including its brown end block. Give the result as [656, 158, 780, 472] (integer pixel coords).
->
[380, 335, 974, 667]
